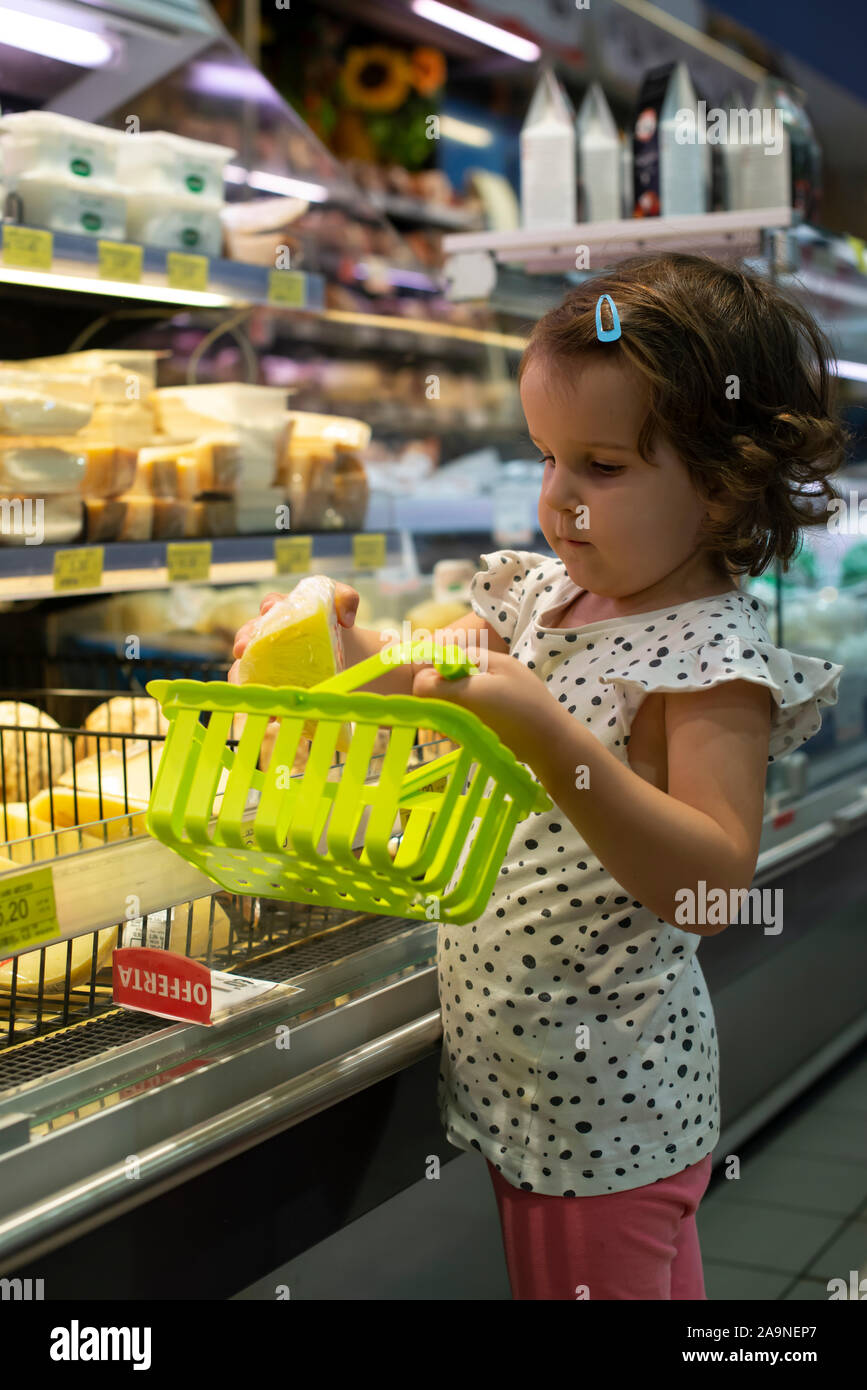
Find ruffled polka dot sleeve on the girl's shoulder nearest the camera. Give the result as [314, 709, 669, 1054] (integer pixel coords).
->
[597, 638, 843, 763]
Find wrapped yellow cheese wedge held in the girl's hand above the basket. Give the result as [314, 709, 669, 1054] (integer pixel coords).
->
[239, 574, 352, 752]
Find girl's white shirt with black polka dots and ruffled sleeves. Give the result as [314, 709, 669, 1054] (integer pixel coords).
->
[438, 550, 842, 1197]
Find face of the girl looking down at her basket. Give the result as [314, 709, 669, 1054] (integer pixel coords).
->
[521, 357, 711, 599]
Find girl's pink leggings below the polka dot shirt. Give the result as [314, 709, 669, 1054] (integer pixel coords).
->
[488, 1154, 711, 1300]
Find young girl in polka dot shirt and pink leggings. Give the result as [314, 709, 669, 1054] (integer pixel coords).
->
[235, 254, 845, 1300]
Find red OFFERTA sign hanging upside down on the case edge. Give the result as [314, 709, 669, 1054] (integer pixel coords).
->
[111, 947, 211, 1023]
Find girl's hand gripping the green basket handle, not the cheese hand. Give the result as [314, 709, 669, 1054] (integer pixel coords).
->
[413, 651, 554, 767]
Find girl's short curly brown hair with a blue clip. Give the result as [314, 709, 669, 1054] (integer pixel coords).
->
[518, 253, 850, 575]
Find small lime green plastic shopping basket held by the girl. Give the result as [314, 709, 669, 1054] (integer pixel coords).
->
[146, 644, 552, 923]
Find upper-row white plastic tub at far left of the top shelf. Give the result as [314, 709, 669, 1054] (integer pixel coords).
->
[0, 111, 124, 186]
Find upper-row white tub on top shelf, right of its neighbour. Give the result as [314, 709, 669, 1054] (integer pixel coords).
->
[118, 131, 236, 203]
